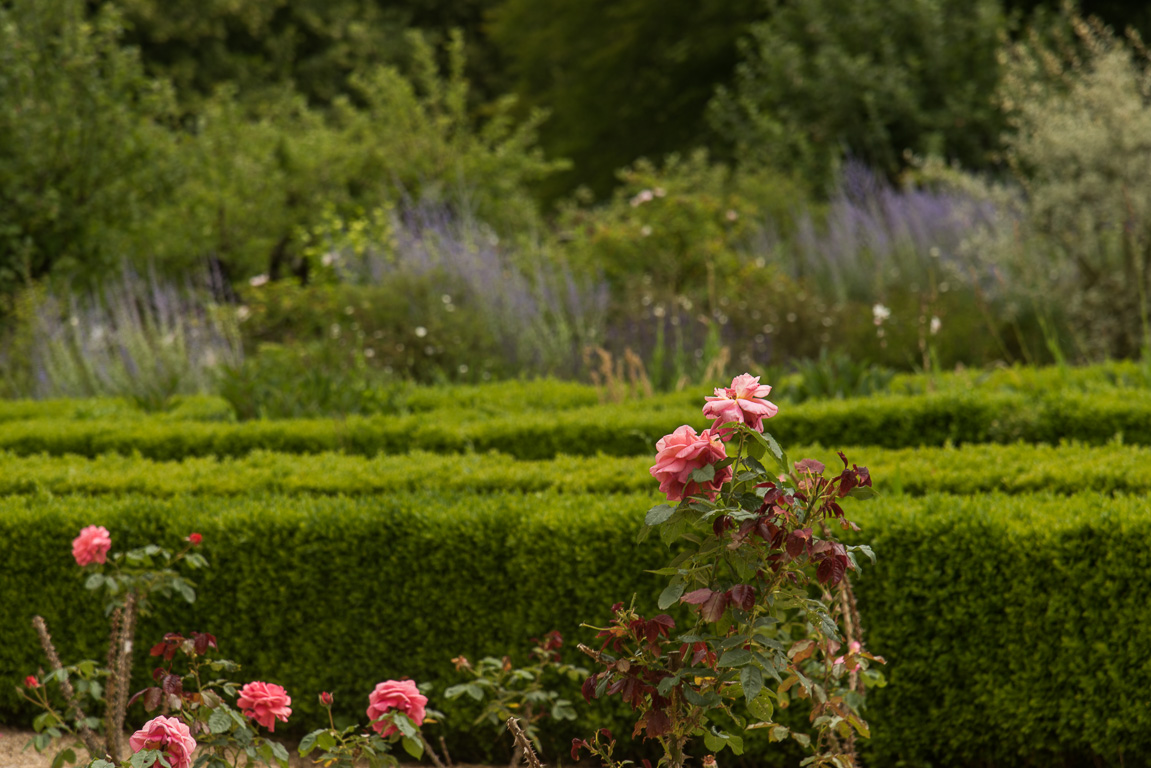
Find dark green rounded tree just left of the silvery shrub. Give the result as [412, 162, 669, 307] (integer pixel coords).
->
[711, 0, 1005, 184]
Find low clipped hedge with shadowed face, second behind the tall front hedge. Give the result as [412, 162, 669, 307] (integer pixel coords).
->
[0, 390, 1151, 461]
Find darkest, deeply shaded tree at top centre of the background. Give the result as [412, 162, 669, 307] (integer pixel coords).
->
[489, 0, 762, 197]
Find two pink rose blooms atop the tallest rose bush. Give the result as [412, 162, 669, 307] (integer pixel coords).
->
[650, 373, 779, 501]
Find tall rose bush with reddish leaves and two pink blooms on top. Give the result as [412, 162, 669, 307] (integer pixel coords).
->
[572, 374, 883, 768]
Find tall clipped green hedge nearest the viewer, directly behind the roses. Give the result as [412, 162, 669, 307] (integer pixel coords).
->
[0, 493, 1151, 766]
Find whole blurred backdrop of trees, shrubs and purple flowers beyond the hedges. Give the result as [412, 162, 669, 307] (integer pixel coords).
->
[0, 0, 1151, 418]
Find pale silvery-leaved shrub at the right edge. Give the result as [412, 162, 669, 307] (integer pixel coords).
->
[1000, 12, 1151, 356]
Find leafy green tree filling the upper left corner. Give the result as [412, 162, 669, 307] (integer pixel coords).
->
[0, 0, 173, 290]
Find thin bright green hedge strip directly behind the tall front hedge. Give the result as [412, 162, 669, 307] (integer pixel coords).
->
[0, 443, 1151, 496]
